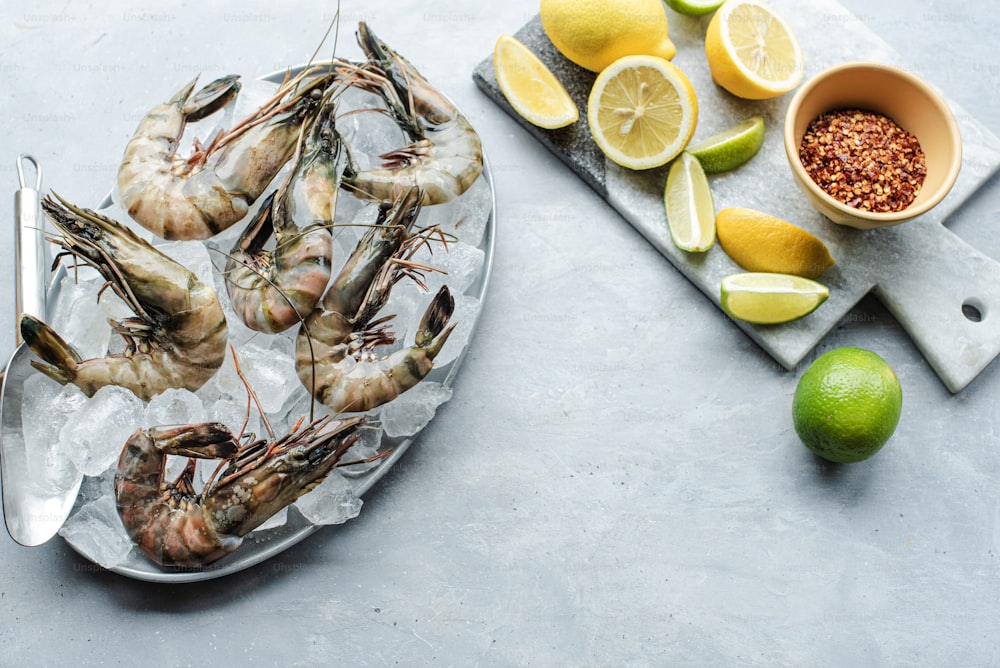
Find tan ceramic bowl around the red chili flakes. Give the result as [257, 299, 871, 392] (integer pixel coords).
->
[785, 62, 962, 230]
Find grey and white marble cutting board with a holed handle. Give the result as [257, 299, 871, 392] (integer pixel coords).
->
[473, 0, 1000, 392]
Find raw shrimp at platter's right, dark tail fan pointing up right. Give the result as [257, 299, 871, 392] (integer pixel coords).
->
[295, 184, 455, 413]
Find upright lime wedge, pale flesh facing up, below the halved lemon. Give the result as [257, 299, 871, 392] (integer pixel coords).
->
[663, 151, 715, 253]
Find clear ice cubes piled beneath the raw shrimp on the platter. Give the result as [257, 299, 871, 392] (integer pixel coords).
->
[31, 78, 493, 568]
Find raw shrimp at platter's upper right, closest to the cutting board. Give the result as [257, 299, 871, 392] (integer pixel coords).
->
[340, 22, 483, 205]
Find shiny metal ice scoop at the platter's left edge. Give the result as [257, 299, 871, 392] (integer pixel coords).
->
[0, 154, 82, 547]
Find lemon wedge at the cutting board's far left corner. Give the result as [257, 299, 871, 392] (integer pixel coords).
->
[493, 35, 580, 130]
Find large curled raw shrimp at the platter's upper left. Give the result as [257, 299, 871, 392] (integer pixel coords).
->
[118, 67, 333, 239]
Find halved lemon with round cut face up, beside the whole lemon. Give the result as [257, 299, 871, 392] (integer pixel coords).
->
[587, 56, 698, 169]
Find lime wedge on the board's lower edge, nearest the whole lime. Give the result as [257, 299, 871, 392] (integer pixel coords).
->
[720, 272, 830, 325]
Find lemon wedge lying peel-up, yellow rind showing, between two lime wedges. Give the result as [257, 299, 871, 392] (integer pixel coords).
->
[715, 207, 835, 278]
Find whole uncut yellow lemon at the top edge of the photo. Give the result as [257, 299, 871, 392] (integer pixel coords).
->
[540, 0, 677, 72]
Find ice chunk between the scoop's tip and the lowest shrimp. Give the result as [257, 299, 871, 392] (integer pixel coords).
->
[59, 482, 132, 568]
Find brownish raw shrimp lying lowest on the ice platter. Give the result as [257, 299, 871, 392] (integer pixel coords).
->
[115, 415, 364, 568]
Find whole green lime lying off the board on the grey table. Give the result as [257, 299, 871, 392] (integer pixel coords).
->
[792, 348, 903, 464]
